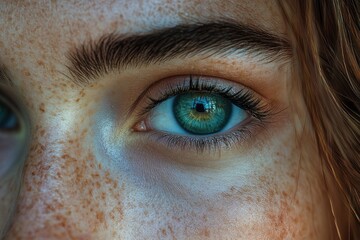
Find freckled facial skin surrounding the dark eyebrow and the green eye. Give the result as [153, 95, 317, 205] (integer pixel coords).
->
[0, 0, 346, 239]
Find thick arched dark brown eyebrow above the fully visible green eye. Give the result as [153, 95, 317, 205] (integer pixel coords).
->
[67, 22, 291, 85]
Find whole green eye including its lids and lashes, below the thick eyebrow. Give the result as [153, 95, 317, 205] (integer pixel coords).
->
[133, 76, 271, 150]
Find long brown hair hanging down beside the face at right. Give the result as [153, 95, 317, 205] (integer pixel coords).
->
[280, 0, 360, 239]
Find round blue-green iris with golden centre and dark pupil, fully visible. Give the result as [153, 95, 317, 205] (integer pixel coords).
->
[173, 92, 232, 135]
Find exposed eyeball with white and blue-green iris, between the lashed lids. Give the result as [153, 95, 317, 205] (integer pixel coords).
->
[149, 92, 248, 135]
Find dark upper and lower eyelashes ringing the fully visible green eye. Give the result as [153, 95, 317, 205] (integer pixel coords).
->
[140, 75, 272, 152]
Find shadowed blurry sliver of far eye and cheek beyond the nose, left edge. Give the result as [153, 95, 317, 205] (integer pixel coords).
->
[0, 92, 28, 239]
